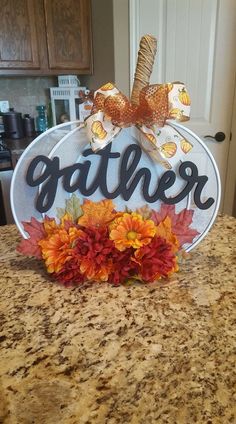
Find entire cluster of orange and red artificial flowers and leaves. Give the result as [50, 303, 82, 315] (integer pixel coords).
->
[18, 195, 198, 285]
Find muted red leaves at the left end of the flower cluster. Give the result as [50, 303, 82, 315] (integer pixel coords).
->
[16, 218, 46, 259]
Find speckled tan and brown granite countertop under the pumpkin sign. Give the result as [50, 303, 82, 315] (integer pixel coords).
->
[0, 216, 236, 424]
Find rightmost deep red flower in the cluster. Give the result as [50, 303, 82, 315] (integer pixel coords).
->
[134, 236, 178, 282]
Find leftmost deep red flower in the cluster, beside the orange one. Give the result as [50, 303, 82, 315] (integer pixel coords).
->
[75, 227, 114, 281]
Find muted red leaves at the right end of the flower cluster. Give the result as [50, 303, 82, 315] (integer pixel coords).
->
[151, 204, 199, 246]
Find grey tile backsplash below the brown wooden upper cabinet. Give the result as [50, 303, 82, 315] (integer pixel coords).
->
[0, 77, 57, 117]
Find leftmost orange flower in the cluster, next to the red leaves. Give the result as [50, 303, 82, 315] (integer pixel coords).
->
[38, 227, 81, 273]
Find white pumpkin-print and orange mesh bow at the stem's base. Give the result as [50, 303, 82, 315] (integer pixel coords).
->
[85, 82, 193, 169]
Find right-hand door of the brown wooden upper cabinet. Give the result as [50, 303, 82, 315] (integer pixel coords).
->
[44, 0, 92, 73]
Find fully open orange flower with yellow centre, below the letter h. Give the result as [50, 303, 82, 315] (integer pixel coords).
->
[110, 212, 156, 251]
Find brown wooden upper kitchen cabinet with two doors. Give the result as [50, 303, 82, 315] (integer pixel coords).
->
[0, 0, 92, 75]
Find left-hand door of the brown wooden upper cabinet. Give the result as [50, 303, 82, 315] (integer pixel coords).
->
[0, 0, 40, 69]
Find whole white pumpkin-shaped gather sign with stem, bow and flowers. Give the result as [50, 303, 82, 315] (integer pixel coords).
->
[11, 36, 220, 285]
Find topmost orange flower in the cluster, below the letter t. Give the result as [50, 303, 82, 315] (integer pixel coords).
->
[78, 200, 116, 227]
